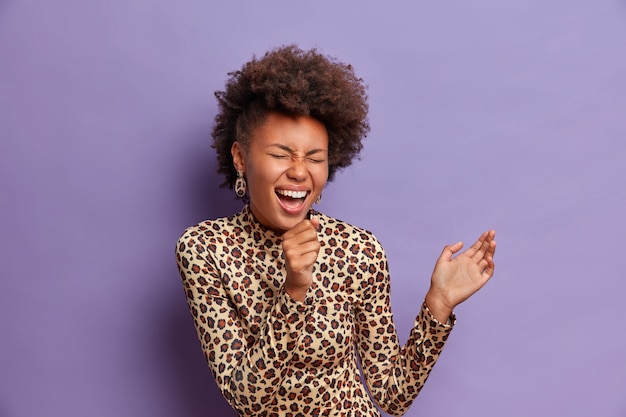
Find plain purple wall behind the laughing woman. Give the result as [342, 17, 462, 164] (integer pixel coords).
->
[0, 0, 626, 417]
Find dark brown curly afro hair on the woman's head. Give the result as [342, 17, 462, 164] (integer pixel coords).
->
[212, 45, 369, 186]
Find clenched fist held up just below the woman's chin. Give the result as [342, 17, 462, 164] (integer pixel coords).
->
[283, 217, 320, 301]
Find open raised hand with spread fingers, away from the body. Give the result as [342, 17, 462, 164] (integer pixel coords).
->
[426, 230, 496, 322]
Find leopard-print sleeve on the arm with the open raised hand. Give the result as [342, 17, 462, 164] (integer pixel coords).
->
[355, 239, 454, 415]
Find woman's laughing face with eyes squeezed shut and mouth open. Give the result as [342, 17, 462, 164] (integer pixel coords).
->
[231, 113, 328, 233]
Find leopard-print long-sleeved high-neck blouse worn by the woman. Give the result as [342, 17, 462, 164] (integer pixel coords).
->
[176, 206, 454, 417]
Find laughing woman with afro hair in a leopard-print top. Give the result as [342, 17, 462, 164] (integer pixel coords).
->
[177, 46, 495, 416]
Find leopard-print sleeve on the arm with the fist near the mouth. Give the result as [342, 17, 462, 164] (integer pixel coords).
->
[176, 230, 311, 416]
